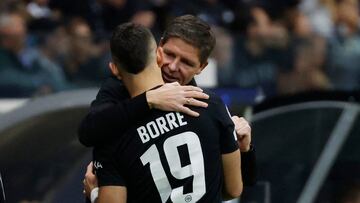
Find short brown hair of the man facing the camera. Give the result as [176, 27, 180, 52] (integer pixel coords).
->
[161, 15, 216, 64]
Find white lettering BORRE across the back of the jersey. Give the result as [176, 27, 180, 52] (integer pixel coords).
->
[137, 112, 187, 144]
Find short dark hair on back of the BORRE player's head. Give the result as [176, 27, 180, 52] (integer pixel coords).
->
[110, 23, 154, 74]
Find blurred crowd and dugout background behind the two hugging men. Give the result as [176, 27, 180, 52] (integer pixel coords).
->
[0, 0, 360, 203]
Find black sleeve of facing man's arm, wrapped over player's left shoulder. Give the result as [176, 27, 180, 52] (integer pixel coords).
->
[78, 78, 151, 147]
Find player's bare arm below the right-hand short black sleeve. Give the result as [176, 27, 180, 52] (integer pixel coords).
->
[221, 150, 243, 200]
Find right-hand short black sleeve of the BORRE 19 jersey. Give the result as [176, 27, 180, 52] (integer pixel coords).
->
[210, 93, 239, 154]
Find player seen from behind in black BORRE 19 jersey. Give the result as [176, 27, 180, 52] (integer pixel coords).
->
[94, 23, 243, 203]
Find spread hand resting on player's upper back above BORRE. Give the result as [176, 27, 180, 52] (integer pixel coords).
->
[146, 82, 209, 117]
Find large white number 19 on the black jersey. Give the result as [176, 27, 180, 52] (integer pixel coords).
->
[140, 132, 206, 203]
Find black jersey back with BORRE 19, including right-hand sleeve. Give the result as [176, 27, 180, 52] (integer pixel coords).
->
[94, 92, 238, 203]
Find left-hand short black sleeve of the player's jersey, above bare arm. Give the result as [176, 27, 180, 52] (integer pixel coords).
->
[93, 146, 126, 187]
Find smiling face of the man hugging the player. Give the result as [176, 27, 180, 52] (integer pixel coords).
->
[159, 38, 207, 85]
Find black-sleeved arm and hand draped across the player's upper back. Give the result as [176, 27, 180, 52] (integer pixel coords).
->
[78, 77, 208, 147]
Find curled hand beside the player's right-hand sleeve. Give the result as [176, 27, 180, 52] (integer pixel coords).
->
[231, 116, 251, 152]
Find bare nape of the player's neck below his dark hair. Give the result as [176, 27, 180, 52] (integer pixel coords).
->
[123, 64, 164, 98]
